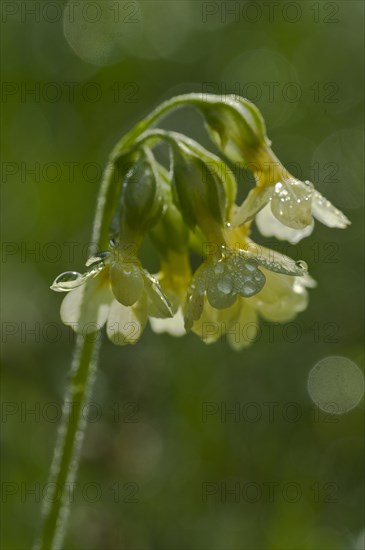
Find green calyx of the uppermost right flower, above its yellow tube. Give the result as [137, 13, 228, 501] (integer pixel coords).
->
[195, 95, 270, 166]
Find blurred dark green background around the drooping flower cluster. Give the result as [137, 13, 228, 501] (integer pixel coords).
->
[1, 0, 364, 550]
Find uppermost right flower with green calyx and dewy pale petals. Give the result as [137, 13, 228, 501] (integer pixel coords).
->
[191, 96, 350, 243]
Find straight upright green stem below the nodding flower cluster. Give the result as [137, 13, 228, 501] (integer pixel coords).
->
[33, 148, 122, 550]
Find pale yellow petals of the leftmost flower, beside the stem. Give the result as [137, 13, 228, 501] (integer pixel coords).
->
[51, 252, 173, 345]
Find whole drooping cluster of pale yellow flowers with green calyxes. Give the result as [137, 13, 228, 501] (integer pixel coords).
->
[51, 94, 350, 349]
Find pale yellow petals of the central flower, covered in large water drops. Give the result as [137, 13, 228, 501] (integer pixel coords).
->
[181, 231, 315, 350]
